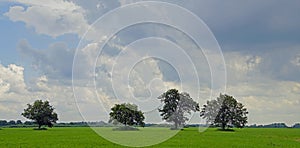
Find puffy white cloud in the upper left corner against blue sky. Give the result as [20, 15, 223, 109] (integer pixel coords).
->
[4, 0, 89, 37]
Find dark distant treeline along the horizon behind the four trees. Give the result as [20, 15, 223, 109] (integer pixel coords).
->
[0, 120, 300, 128]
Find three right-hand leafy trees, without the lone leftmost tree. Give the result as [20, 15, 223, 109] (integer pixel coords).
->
[110, 89, 248, 130]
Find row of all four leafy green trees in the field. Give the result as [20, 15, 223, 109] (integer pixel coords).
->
[18, 89, 248, 130]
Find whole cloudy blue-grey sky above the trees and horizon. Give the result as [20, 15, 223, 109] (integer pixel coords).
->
[0, 0, 300, 125]
